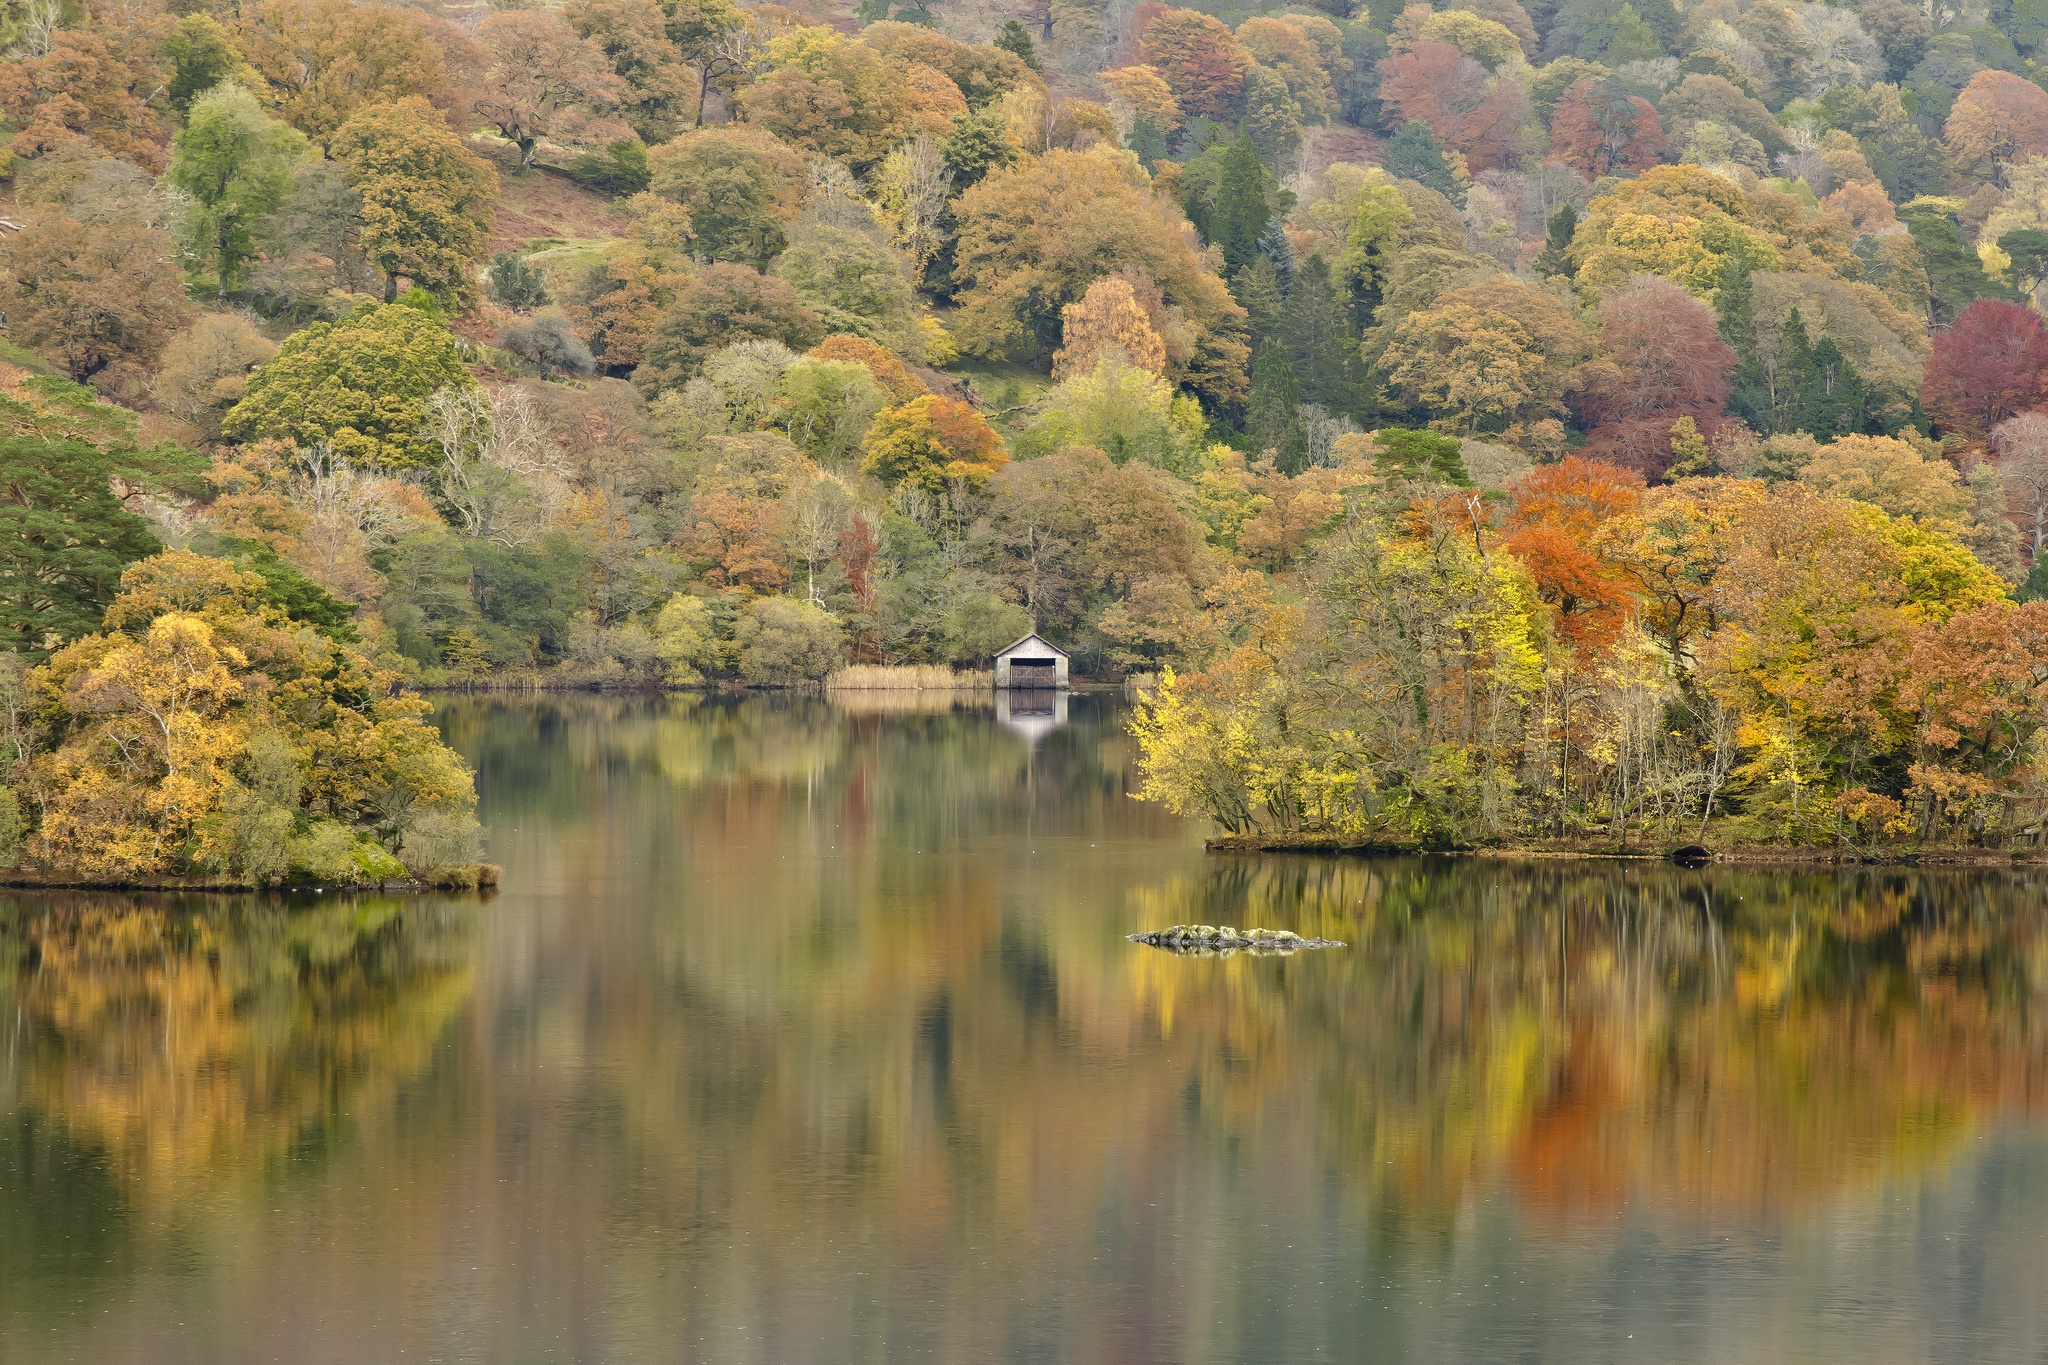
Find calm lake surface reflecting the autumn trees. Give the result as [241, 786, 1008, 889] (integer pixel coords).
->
[0, 698, 2048, 1365]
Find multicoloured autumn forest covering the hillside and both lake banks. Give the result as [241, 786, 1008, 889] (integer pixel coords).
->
[0, 0, 2048, 884]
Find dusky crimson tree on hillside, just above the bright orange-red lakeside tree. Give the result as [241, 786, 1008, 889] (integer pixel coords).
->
[1579, 276, 1735, 475]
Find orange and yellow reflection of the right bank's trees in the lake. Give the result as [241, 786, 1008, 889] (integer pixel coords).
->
[1135, 860, 2048, 1212]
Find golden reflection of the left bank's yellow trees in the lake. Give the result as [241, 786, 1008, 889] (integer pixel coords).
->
[0, 894, 469, 1207]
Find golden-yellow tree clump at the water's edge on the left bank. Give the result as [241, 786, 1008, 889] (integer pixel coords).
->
[12, 551, 477, 884]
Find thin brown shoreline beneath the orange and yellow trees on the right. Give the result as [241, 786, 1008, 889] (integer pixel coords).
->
[1202, 835, 2048, 868]
